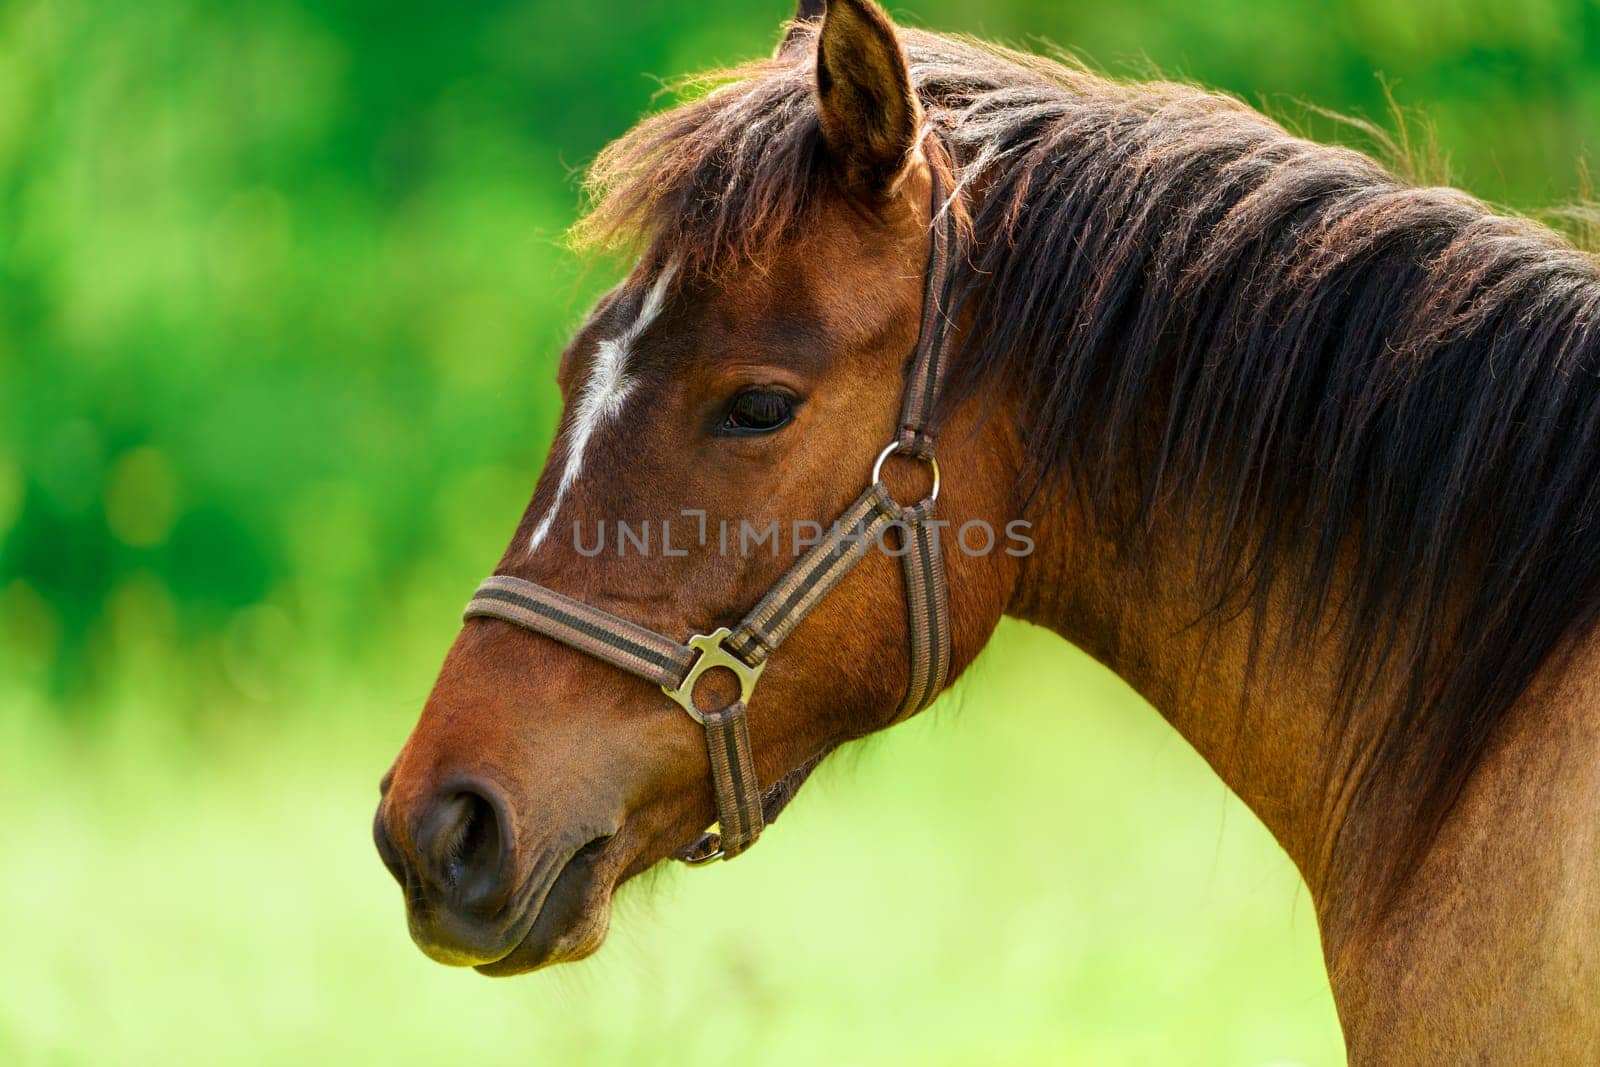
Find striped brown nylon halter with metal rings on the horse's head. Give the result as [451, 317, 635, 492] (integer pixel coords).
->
[464, 166, 957, 864]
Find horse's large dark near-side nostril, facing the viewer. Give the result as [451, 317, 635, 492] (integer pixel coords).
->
[416, 779, 512, 913]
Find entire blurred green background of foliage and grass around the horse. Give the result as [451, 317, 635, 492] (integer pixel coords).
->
[0, 0, 1600, 1064]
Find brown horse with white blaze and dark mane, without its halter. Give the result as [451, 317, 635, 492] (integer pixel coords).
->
[376, 0, 1600, 1062]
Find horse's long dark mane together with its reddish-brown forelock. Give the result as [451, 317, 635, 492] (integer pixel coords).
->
[578, 30, 1600, 895]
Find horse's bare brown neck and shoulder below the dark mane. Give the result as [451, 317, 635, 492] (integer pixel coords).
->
[1008, 454, 1600, 1062]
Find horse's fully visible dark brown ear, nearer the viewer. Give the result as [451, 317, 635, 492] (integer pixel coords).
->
[819, 0, 922, 197]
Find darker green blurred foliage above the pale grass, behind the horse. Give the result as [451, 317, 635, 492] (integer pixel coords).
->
[0, 0, 1600, 713]
